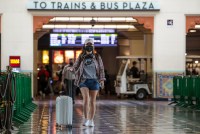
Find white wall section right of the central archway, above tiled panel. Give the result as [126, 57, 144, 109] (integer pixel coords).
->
[153, 0, 200, 72]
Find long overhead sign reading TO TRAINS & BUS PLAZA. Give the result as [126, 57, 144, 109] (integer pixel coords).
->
[27, 0, 160, 11]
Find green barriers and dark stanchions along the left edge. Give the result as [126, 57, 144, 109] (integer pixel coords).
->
[0, 66, 37, 132]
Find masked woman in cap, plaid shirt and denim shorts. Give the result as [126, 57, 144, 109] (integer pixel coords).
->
[71, 39, 105, 127]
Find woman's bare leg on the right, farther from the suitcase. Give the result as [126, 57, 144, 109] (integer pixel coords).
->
[89, 90, 98, 120]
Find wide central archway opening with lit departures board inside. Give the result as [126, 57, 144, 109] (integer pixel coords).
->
[33, 16, 154, 96]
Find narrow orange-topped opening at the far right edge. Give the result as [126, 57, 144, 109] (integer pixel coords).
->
[185, 16, 200, 75]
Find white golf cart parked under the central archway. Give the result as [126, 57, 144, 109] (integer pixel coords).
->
[115, 56, 152, 100]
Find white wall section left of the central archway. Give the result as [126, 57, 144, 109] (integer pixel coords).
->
[0, 0, 33, 72]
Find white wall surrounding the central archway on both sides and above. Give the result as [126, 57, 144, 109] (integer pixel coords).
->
[0, 0, 200, 98]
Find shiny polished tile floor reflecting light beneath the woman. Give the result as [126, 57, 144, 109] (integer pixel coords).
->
[8, 97, 200, 134]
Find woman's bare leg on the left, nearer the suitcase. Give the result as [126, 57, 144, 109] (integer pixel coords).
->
[80, 87, 90, 119]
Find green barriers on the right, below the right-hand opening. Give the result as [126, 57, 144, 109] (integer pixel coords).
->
[173, 76, 200, 109]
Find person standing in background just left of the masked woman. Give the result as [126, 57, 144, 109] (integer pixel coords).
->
[61, 59, 76, 104]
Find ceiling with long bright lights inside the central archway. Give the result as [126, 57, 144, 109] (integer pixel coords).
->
[35, 17, 151, 40]
